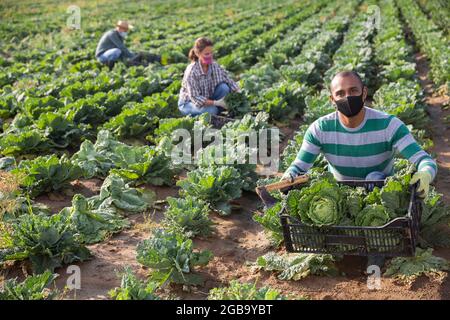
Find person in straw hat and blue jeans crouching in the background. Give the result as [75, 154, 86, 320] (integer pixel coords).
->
[95, 20, 135, 69]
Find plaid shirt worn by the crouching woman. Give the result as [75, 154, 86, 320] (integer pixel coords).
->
[180, 61, 239, 107]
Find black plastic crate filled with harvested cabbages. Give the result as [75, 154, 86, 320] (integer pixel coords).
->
[279, 180, 422, 257]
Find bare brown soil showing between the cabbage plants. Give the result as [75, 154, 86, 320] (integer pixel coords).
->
[1, 59, 450, 300]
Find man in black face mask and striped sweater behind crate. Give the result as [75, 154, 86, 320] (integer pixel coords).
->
[283, 71, 437, 265]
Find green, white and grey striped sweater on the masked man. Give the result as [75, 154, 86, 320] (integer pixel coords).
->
[286, 107, 437, 180]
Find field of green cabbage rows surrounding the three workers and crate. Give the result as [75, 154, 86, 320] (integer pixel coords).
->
[0, 0, 450, 300]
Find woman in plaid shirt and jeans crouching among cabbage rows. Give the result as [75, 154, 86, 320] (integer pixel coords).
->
[178, 37, 239, 116]
